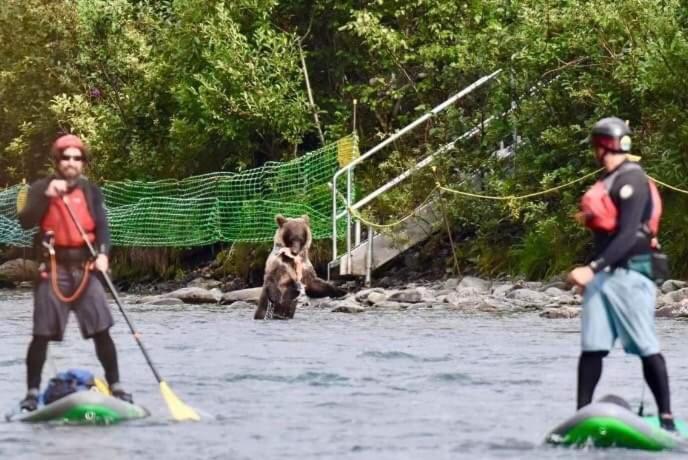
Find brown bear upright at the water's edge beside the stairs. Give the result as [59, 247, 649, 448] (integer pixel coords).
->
[253, 214, 346, 319]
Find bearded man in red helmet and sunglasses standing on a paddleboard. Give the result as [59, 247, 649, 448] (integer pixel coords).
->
[19, 134, 132, 411]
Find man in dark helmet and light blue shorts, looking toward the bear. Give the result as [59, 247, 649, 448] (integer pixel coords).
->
[569, 117, 675, 430]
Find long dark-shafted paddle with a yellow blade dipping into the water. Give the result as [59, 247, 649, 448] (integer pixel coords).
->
[62, 195, 201, 420]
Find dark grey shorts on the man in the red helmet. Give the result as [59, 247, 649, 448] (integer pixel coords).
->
[33, 265, 114, 341]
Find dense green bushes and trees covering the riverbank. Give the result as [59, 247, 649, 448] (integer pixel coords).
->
[0, 0, 688, 278]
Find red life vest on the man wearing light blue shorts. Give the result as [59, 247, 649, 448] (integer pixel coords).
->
[581, 163, 662, 236]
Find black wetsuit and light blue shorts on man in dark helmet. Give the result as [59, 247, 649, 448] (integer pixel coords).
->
[578, 161, 671, 428]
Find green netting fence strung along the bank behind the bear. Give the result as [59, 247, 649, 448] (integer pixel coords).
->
[0, 135, 358, 247]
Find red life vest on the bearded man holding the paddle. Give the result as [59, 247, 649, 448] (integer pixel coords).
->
[41, 187, 96, 248]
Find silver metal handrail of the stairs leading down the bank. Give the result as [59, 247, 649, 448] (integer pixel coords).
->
[332, 69, 502, 270]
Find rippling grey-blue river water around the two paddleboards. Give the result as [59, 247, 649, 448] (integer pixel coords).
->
[0, 291, 688, 460]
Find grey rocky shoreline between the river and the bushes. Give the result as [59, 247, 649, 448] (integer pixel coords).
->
[5, 259, 688, 319]
